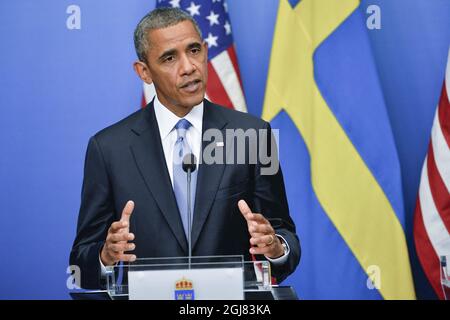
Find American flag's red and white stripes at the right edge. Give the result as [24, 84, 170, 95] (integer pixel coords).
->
[414, 50, 450, 299]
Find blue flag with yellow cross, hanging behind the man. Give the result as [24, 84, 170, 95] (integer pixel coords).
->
[263, 0, 415, 299]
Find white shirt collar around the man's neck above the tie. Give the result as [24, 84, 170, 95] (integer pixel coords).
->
[153, 95, 203, 140]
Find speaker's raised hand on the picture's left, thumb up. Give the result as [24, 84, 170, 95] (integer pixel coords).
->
[100, 201, 136, 266]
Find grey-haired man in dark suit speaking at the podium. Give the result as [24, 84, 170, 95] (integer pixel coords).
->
[70, 9, 300, 288]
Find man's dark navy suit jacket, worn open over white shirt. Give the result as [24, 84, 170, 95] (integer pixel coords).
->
[70, 100, 300, 288]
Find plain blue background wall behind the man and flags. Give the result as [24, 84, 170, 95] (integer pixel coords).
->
[0, 0, 450, 299]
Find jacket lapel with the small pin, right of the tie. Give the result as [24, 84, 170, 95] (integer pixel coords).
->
[192, 99, 227, 248]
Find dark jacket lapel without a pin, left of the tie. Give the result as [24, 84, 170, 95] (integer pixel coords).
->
[131, 102, 187, 252]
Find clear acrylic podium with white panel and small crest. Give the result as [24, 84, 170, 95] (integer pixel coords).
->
[106, 256, 272, 300]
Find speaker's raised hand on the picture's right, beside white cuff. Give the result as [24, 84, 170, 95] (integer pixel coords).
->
[238, 200, 284, 259]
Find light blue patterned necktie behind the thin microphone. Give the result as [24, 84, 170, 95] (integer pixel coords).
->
[173, 119, 197, 239]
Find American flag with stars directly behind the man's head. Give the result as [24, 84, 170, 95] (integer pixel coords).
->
[144, 0, 247, 112]
